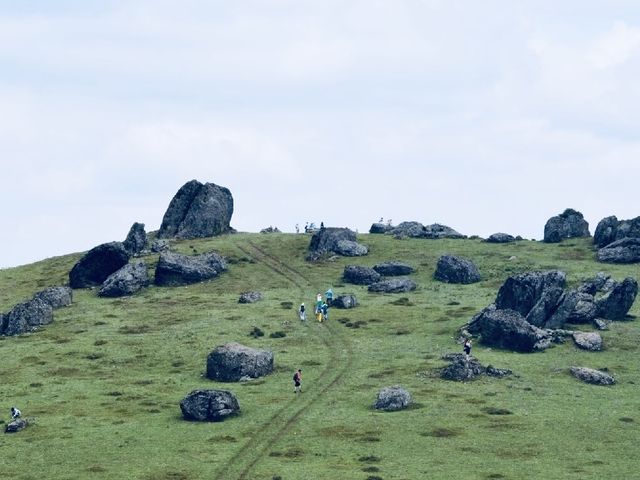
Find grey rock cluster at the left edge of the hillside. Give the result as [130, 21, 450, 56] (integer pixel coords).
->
[0, 287, 73, 336]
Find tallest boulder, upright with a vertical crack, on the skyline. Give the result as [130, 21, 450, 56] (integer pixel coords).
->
[158, 180, 233, 238]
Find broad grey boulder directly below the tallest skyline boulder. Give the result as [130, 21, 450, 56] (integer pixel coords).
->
[155, 252, 227, 286]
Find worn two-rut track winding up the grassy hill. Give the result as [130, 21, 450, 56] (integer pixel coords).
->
[214, 241, 353, 480]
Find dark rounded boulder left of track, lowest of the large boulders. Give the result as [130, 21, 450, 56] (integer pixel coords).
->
[180, 390, 240, 422]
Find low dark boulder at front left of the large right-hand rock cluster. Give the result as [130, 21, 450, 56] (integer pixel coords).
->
[467, 305, 551, 352]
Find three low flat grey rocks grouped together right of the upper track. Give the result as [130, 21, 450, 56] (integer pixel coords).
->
[342, 261, 417, 293]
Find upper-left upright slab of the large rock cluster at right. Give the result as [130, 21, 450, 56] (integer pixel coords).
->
[496, 270, 567, 317]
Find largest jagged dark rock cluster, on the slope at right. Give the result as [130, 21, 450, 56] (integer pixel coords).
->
[466, 270, 638, 352]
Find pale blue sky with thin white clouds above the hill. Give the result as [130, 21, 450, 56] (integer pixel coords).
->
[0, 0, 640, 268]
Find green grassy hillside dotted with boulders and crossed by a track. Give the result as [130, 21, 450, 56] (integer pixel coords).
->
[0, 234, 640, 480]
